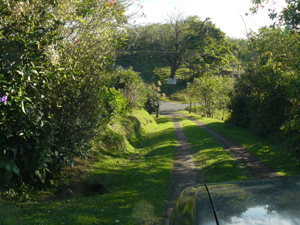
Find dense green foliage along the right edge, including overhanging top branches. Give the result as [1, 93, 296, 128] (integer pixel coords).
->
[229, 0, 300, 150]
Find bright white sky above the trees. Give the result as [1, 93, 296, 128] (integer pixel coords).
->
[131, 0, 284, 38]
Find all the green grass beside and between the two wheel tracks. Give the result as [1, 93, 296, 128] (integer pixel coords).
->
[0, 107, 300, 225]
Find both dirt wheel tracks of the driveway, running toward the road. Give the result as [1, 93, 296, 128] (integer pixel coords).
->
[161, 111, 281, 225]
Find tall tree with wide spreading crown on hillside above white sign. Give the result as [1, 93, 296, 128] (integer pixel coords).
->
[155, 11, 230, 78]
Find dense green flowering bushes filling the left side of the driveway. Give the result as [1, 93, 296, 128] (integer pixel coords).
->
[0, 0, 146, 197]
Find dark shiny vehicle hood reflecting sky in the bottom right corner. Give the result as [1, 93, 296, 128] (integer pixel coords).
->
[170, 176, 300, 225]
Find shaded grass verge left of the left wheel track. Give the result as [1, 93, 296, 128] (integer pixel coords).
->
[0, 111, 176, 225]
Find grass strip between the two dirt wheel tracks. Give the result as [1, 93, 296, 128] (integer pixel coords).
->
[180, 118, 254, 183]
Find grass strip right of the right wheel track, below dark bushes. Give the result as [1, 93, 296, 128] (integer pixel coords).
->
[180, 111, 300, 176]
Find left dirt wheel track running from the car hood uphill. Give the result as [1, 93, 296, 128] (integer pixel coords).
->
[165, 114, 197, 225]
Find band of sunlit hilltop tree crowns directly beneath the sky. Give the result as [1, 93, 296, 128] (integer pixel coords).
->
[125, 11, 230, 78]
